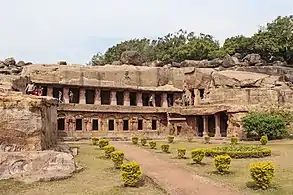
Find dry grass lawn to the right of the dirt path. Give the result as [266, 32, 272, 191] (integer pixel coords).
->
[141, 140, 293, 195]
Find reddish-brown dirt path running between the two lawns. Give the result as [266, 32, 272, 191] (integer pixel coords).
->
[114, 142, 241, 195]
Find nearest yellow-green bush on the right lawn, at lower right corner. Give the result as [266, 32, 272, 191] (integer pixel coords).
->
[249, 162, 275, 189]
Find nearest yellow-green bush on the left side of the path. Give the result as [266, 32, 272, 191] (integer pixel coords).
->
[121, 162, 142, 187]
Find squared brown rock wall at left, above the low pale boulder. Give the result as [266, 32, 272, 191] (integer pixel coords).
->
[0, 92, 57, 151]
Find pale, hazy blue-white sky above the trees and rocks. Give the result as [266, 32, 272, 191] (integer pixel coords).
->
[0, 0, 293, 64]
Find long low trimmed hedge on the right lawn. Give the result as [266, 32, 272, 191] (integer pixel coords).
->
[206, 145, 272, 158]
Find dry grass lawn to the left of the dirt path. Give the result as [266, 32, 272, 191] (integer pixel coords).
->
[0, 144, 165, 195]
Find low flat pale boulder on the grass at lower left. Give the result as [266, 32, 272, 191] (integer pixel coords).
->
[0, 150, 78, 183]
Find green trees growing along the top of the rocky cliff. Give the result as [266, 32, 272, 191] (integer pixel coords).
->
[91, 16, 293, 65]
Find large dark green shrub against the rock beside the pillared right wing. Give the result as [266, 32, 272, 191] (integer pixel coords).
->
[242, 112, 287, 139]
